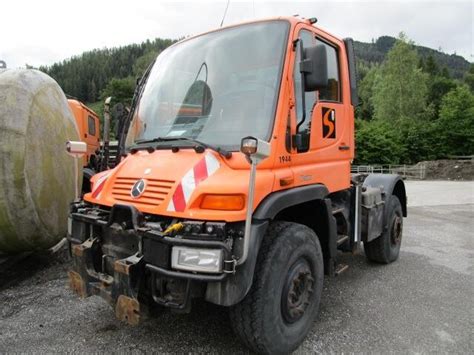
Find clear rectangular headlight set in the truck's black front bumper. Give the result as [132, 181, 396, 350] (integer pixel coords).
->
[171, 247, 223, 273]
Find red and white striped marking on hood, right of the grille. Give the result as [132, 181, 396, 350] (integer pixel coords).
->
[168, 153, 220, 212]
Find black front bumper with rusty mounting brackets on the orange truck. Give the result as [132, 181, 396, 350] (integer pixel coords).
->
[68, 205, 241, 324]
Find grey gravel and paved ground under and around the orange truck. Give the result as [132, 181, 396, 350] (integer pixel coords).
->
[0, 181, 474, 354]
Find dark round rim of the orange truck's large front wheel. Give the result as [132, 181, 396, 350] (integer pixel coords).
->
[281, 258, 314, 323]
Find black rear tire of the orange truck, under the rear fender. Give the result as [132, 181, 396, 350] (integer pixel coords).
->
[364, 195, 403, 264]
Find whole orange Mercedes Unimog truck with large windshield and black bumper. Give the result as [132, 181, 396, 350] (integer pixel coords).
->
[68, 17, 407, 353]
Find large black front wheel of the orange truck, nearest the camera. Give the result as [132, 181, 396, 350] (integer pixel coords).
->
[230, 222, 324, 354]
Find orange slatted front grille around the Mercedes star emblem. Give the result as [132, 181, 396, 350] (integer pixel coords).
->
[112, 177, 174, 206]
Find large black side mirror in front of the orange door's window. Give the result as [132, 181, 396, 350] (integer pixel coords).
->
[300, 44, 328, 91]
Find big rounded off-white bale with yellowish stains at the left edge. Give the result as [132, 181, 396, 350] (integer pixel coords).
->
[0, 70, 82, 254]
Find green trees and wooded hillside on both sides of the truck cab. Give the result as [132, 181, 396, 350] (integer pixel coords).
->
[40, 33, 474, 164]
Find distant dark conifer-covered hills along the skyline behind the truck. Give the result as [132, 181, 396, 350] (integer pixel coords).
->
[40, 36, 469, 103]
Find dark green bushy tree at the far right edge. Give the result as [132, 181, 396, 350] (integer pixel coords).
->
[437, 85, 474, 155]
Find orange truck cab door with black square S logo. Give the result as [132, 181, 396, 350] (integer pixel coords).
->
[292, 28, 353, 191]
